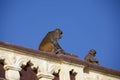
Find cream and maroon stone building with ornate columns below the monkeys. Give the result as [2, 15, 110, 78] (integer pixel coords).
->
[0, 42, 120, 80]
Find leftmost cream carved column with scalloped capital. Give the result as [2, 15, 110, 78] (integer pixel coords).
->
[0, 52, 29, 80]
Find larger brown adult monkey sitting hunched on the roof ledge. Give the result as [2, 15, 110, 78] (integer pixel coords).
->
[39, 28, 64, 54]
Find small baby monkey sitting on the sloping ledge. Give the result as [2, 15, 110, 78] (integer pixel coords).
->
[84, 49, 99, 64]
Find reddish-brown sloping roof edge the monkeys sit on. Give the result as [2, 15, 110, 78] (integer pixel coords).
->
[0, 41, 120, 77]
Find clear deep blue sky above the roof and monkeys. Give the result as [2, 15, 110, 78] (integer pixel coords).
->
[0, 0, 120, 70]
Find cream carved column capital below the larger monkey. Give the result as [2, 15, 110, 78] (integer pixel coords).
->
[31, 61, 60, 80]
